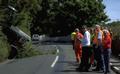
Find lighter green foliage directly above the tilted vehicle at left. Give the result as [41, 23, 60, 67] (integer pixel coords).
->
[9, 0, 41, 35]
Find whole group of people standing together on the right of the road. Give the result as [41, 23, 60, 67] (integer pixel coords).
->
[71, 25, 112, 74]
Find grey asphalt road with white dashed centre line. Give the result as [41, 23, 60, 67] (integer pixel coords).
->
[0, 44, 115, 74]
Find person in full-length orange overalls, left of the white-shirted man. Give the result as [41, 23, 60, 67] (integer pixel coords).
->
[74, 28, 83, 63]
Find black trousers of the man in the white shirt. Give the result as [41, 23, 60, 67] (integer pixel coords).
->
[79, 46, 92, 71]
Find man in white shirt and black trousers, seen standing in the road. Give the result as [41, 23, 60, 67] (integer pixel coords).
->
[77, 26, 91, 71]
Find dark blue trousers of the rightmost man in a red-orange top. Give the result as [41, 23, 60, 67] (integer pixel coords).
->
[102, 49, 111, 73]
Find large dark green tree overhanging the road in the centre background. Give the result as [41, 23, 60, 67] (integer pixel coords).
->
[31, 0, 108, 35]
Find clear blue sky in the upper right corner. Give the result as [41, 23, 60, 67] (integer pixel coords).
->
[103, 0, 120, 21]
